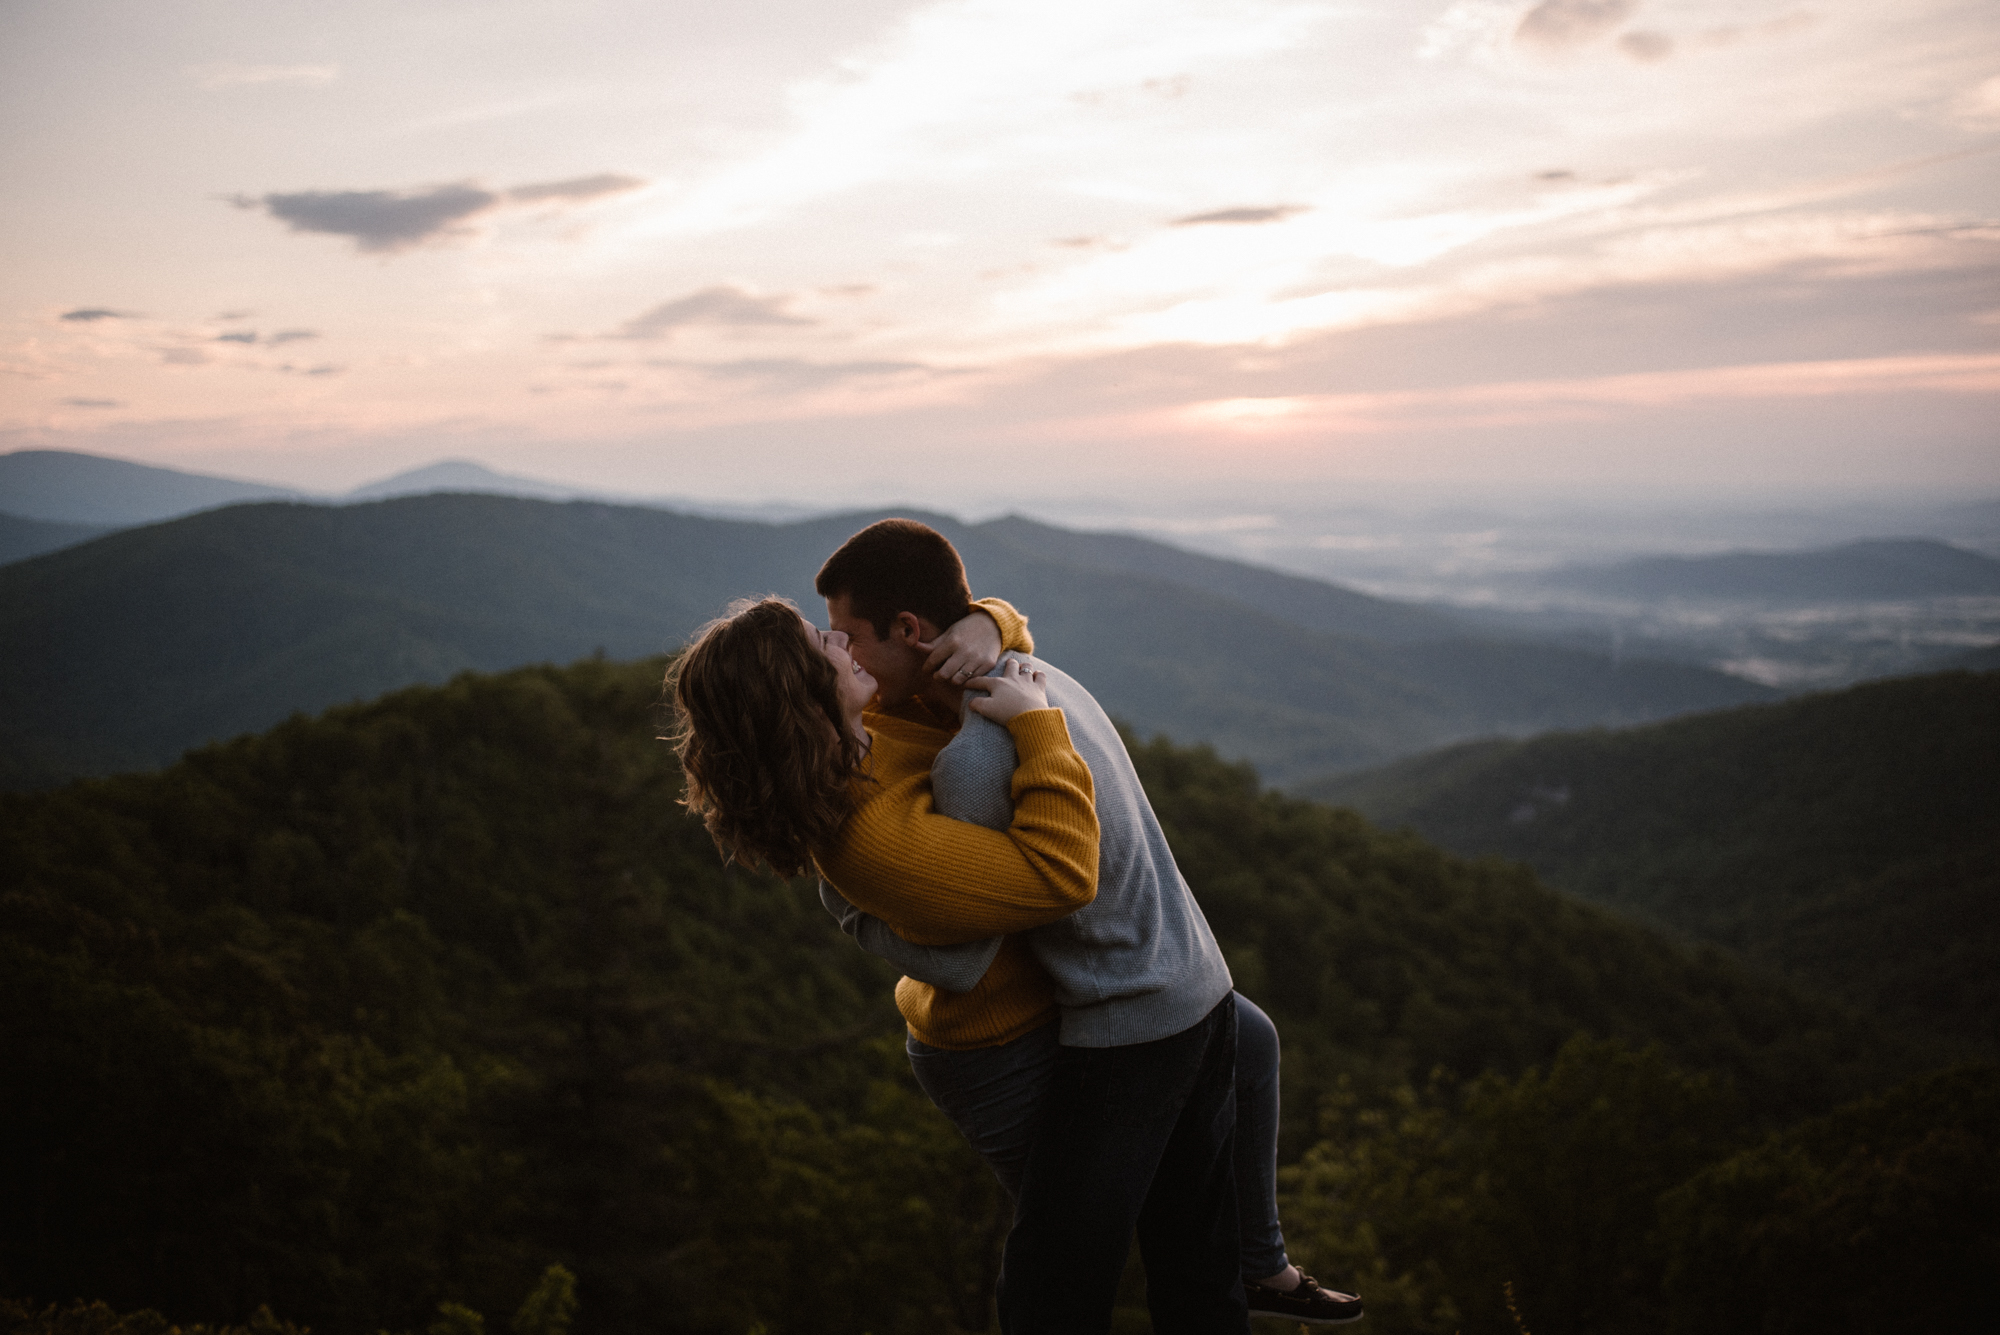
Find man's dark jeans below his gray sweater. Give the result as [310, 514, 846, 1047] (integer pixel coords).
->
[1000, 997, 1250, 1335]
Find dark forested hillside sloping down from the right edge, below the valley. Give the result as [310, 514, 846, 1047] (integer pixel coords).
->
[1300, 671, 2000, 1051]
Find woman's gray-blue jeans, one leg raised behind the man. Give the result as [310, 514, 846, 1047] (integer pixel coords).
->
[906, 993, 1288, 1279]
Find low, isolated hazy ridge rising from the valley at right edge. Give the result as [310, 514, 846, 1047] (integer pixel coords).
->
[1534, 538, 2000, 602]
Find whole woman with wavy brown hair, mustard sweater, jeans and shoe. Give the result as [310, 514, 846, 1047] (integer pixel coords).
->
[670, 600, 1360, 1323]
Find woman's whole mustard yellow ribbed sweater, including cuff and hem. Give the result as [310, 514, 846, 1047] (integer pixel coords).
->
[818, 604, 1098, 1049]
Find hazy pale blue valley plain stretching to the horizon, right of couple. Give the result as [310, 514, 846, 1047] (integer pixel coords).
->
[1020, 500, 2000, 689]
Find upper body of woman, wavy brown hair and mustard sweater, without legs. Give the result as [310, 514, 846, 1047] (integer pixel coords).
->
[670, 598, 1098, 1047]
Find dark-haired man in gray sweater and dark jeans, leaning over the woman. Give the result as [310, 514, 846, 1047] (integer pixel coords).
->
[816, 520, 1248, 1335]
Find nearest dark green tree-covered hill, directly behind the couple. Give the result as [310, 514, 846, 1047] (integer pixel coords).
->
[0, 660, 1958, 1335]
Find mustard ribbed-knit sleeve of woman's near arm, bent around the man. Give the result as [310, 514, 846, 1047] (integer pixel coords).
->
[818, 709, 1098, 945]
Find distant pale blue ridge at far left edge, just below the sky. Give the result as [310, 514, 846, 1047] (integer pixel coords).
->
[0, 450, 298, 528]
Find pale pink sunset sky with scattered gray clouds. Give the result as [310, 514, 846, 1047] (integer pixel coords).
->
[0, 0, 2000, 510]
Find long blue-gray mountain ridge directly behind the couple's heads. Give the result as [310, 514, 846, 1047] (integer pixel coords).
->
[0, 496, 1772, 787]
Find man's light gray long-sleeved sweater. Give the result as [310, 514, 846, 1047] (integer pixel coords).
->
[820, 652, 1230, 1047]
